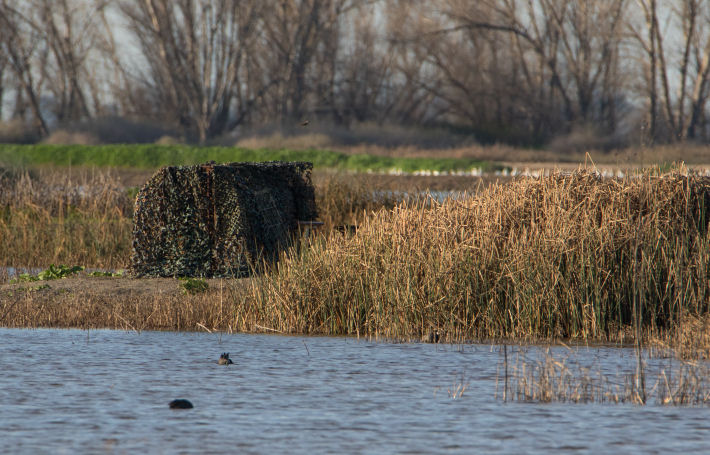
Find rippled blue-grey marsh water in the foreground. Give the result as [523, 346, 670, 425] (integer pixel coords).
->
[0, 329, 710, 454]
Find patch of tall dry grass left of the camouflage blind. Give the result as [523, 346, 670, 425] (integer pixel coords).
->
[0, 170, 133, 268]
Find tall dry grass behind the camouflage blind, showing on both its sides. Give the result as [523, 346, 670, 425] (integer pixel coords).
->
[0, 168, 401, 270]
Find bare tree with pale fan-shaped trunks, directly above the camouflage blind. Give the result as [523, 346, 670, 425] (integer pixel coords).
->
[121, 0, 261, 142]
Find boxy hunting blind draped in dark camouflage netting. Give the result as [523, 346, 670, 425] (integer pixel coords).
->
[130, 161, 317, 277]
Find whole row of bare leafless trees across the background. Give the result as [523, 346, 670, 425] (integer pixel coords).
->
[0, 0, 710, 148]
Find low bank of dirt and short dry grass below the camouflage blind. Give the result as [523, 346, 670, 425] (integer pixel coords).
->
[0, 276, 254, 332]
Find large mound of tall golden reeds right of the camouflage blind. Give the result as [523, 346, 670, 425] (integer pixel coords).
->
[243, 168, 710, 340]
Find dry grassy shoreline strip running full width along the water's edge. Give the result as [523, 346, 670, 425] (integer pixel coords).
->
[0, 272, 710, 350]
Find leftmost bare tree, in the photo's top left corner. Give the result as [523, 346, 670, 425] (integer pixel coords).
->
[0, 0, 106, 135]
